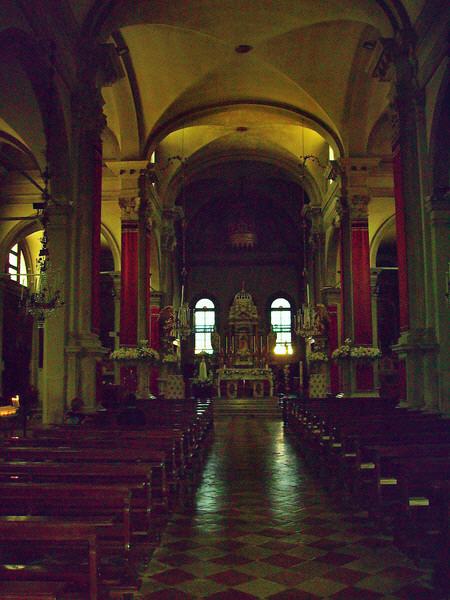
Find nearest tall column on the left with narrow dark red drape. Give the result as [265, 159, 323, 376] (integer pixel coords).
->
[65, 81, 106, 410]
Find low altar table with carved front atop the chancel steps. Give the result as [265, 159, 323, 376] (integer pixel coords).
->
[217, 368, 273, 398]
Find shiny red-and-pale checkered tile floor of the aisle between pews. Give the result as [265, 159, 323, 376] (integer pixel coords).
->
[142, 417, 438, 600]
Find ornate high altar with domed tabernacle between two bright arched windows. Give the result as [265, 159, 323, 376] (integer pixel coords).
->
[217, 288, 275, 398]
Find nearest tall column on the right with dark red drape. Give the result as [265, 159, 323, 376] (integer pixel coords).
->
[388, 48, 438, 409]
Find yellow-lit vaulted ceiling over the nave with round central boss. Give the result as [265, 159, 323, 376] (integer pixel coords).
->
[85, 0, 423, 195]
